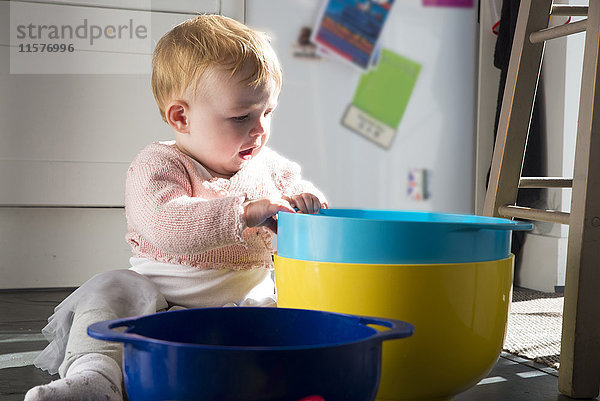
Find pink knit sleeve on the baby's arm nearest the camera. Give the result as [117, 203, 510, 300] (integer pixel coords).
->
[125, 148, 246, 254]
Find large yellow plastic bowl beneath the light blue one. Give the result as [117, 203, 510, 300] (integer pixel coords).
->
[275, 255, 513, 401]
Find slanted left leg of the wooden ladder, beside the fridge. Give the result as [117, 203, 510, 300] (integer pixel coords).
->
[483, 0, 552, 216]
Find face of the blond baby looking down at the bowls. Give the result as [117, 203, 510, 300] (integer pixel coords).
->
[178, 66, 279, 178]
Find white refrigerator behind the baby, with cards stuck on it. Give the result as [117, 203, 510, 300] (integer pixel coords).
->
[245, 0, 478, 213]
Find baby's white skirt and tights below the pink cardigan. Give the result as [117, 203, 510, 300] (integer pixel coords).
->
[25, 260, 275, 401]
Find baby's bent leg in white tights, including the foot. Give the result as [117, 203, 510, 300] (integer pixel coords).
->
[25, 270, 167, 401]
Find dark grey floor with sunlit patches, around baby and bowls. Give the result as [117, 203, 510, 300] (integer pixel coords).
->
[0, 290, 596, 401]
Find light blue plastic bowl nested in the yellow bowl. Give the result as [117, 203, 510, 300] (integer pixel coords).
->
[277, 209, 532, 264]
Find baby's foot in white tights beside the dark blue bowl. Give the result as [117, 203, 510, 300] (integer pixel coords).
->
[24, 354, 123, 401]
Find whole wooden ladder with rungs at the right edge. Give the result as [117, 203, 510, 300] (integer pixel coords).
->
[483, 0, 600, 398]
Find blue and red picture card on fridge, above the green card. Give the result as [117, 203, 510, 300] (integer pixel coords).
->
[311, 0, 394, 69]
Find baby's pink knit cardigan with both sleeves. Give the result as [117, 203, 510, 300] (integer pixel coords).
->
[125, 142, 325, 270]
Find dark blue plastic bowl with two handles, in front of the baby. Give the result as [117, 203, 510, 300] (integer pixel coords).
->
[88, 307, 413, 401]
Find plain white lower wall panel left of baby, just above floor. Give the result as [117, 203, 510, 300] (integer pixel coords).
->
[0, 207, 131, 288]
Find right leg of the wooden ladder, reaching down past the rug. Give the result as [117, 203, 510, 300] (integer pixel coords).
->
[559, 0, 600, 398]
